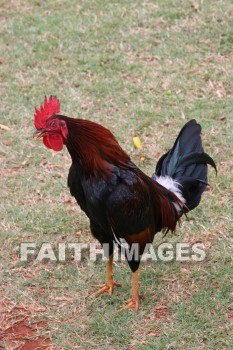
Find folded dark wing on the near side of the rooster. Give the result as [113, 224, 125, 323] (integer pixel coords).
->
[106, 168, 154, 254]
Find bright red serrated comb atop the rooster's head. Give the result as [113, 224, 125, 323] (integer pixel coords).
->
[34, 96, 60, 130]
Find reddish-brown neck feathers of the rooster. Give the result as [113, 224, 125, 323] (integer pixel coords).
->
[62, 117, 131, 177]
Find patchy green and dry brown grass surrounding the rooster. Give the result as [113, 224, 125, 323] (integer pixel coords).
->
[0, 0, 233, 350]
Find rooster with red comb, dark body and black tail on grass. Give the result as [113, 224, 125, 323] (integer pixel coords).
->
[34, 96, 216, 311]
